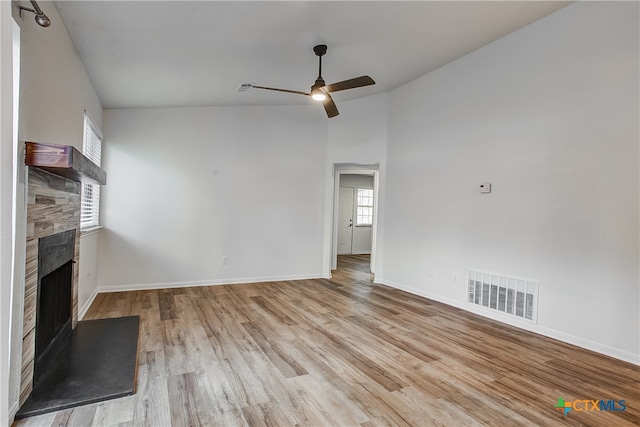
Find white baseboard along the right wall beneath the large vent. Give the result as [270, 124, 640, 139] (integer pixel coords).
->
[375, 277, 640, 366]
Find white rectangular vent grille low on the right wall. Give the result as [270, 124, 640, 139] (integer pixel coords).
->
[468, 270, 538, 323]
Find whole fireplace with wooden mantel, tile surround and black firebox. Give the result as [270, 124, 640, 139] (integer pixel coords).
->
[19, 146, 106, 406]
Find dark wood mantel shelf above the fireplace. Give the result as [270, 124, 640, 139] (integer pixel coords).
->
[24, 141, 107, 185]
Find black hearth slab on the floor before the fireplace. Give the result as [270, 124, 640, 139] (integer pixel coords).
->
[16, 316, 140, 419]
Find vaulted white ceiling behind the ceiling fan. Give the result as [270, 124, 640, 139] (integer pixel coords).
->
[56, 1, 568, 108]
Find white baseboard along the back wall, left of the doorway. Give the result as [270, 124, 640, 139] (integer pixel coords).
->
[96, 273, 331, 293]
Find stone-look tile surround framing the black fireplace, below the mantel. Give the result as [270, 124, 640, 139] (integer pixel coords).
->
[20, 167, 82, 405]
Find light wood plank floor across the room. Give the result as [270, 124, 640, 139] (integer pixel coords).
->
[16, 256, 640, 426]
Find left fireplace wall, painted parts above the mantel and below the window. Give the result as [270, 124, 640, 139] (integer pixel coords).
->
[18, 2, 102, 316]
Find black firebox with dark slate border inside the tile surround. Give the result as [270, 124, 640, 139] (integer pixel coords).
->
[33, 230, 76, 383]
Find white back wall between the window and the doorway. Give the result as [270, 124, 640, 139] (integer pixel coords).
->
[99, 105, 327, 291]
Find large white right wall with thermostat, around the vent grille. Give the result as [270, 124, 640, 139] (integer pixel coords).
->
[381, 2, 640, 363]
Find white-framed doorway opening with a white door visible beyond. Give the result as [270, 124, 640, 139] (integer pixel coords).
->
[331, 164, 379, 273]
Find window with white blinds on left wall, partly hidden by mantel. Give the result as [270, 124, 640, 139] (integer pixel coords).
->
[80, 114, 102, 230]
